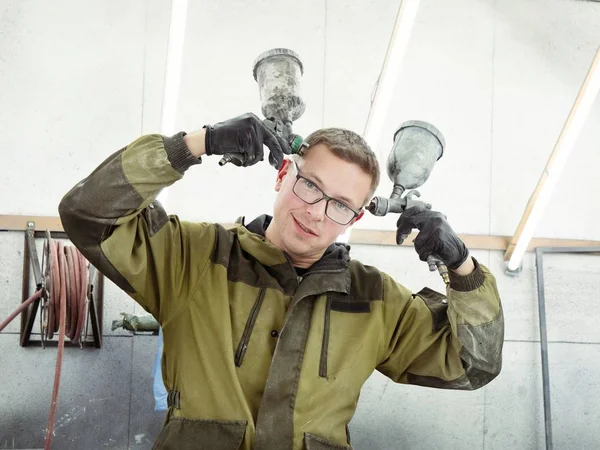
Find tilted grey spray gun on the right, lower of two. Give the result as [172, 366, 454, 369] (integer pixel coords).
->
[367, 120, 450, 284]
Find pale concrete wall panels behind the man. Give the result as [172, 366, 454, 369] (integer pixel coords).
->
[0, 0, 600, 449]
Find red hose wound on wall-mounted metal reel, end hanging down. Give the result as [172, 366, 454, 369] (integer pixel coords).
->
[0, 222, 103, 449]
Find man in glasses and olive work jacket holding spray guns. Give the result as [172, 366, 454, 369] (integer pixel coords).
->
[60, 114, 504, 450]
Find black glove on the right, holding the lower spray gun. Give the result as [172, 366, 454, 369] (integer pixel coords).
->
[396, 206, 469, 269]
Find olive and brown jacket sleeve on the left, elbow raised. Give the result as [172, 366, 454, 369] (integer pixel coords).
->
[59, 133, 215, 326]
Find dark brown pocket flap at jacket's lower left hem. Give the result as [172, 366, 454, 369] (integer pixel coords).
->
[153, 417, 247, 450]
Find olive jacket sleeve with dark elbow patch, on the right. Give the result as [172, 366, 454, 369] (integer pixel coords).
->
[377, 260, 504, 390]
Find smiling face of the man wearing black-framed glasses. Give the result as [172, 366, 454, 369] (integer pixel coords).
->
[267, 144, 371, 267]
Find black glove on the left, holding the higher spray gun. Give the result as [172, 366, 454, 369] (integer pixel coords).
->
[204, 113, 292, 169]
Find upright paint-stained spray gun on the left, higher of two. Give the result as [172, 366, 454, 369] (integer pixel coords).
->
[219, 48, 308, 166]
